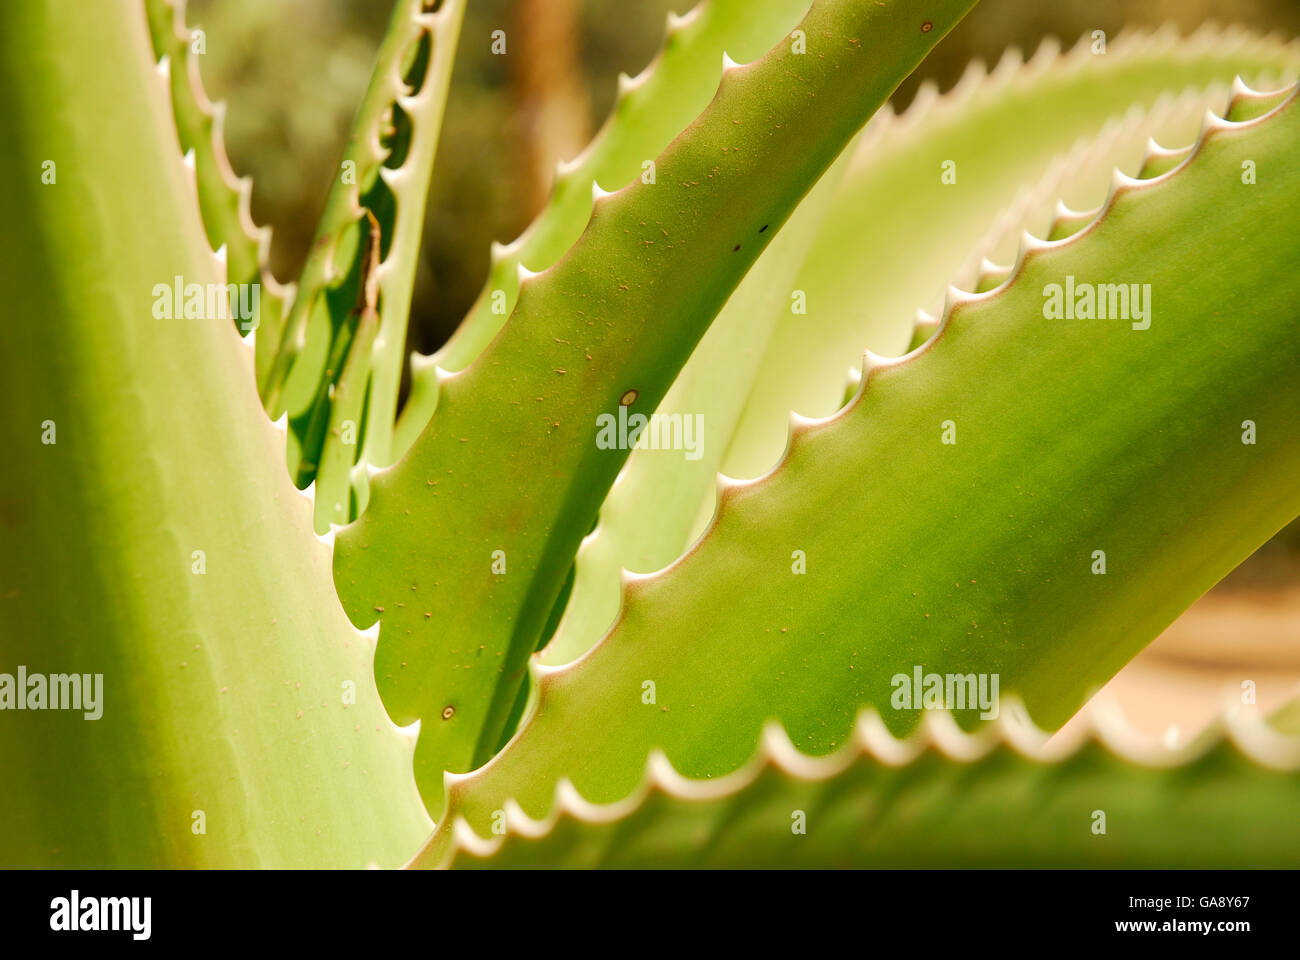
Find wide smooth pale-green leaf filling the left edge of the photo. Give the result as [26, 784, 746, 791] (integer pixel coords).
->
[0, 0, 429, 868]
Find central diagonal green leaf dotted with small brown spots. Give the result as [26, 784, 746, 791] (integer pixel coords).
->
[334, 0, 972, 810]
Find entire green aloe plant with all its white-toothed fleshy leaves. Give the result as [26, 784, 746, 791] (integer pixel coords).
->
[0, 0, 1300, 866]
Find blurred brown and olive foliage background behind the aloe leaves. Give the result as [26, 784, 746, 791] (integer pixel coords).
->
[189, 0, 1300, 624]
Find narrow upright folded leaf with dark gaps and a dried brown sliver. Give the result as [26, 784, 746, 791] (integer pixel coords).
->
[263, 0, 465, 532]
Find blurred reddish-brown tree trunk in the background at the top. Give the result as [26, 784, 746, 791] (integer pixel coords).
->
[510, 0, 592, 213]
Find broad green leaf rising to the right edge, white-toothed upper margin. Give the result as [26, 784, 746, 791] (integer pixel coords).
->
[413, 85, 1300, 835]
